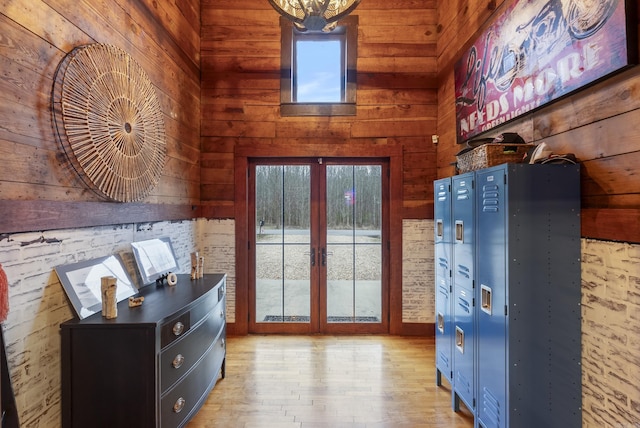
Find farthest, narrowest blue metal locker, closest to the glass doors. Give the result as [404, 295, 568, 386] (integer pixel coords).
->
[433, 178, 454, 386]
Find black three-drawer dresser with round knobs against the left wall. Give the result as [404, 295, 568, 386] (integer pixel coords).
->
[61, 274, 226, 428]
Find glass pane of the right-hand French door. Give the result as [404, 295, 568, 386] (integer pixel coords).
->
[326, 165, 382, 323]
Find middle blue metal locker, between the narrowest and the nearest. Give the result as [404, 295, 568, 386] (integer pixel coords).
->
[451, 172, 476, 413]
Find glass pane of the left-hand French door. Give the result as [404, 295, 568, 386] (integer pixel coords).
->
[255, 165, 311, 323]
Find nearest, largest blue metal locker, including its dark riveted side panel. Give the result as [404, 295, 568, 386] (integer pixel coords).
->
[476, 164, 582, 428]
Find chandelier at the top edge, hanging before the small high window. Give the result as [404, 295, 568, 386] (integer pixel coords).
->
[269, 0, 360, 32]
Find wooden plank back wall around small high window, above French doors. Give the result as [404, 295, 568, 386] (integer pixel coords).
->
[201, 0, 438, 218]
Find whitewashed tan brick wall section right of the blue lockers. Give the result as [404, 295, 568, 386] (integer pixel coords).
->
[582, 239, 640, 428]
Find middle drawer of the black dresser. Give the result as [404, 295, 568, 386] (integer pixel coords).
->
[160, 300, 225, 391]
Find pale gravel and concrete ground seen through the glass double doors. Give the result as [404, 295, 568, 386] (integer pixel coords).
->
[256, 233, 382, 320]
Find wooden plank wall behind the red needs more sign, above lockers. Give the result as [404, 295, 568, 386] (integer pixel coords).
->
[437, 0, 640, 242]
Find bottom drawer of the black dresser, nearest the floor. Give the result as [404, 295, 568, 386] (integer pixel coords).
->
[160, 329, 226, 427]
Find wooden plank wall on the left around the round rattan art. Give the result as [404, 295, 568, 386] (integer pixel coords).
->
[0, 0, 200, 233]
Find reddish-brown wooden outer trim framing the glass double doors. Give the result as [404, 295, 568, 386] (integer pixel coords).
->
[232, 143, 403, 335]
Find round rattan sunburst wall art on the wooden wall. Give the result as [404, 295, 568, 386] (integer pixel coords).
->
[51, 43, 166, 202]
